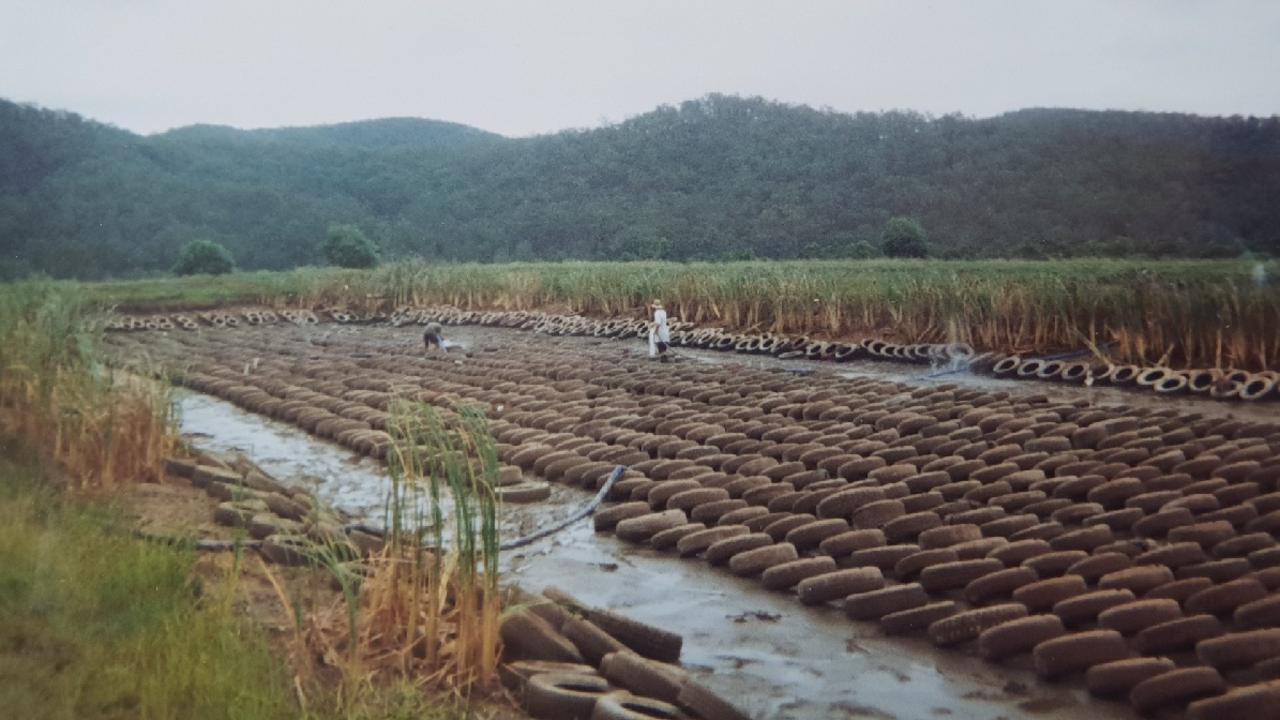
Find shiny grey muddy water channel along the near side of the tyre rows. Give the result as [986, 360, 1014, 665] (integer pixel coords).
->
[177, 384, 1132, 720]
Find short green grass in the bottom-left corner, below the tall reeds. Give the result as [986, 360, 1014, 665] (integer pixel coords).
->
[0, 448, 297, 720]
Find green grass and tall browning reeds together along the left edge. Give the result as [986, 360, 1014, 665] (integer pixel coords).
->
[0, 283, 297, 719]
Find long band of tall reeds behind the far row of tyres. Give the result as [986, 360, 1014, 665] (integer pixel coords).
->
[86, 260, 1280, 369]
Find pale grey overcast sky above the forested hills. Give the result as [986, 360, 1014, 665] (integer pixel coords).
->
[0, 0, 1280, 136]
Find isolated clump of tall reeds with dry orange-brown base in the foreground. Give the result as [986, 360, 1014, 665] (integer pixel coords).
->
[290, 402, 502, 698]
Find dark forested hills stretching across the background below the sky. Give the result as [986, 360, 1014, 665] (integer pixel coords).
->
[0, 96, 1280, 278]
